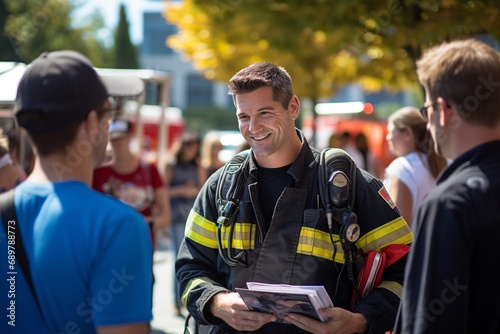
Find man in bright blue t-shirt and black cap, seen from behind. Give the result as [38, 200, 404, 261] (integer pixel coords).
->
[0, 51, 152, 334]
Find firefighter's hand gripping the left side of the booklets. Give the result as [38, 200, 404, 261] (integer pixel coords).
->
[210, 292, 277, 331]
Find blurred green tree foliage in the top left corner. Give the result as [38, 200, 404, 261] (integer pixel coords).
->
[0, 0, 107, 66]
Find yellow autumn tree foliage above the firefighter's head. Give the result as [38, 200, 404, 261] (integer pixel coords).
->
[165, 0, 500, 101]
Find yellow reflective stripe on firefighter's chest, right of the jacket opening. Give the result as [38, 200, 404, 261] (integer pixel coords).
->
[297, 227, 344, 263]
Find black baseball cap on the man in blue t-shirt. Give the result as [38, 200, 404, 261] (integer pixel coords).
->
[14, 50, 108, 133]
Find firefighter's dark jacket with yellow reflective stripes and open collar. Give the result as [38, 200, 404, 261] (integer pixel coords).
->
[176, 130, 413, 333]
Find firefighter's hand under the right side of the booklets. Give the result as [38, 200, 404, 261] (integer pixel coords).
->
[285, 307, 368, 334]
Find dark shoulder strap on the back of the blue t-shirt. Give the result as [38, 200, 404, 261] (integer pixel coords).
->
[0, 189, 40, 308]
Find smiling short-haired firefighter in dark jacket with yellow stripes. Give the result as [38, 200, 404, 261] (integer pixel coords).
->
[176, 62, 412, 333]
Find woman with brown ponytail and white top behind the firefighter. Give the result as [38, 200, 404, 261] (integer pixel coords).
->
[384, 107, 447, 229]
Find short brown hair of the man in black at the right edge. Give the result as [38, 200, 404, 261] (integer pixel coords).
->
[417, 39, 500, 127]
